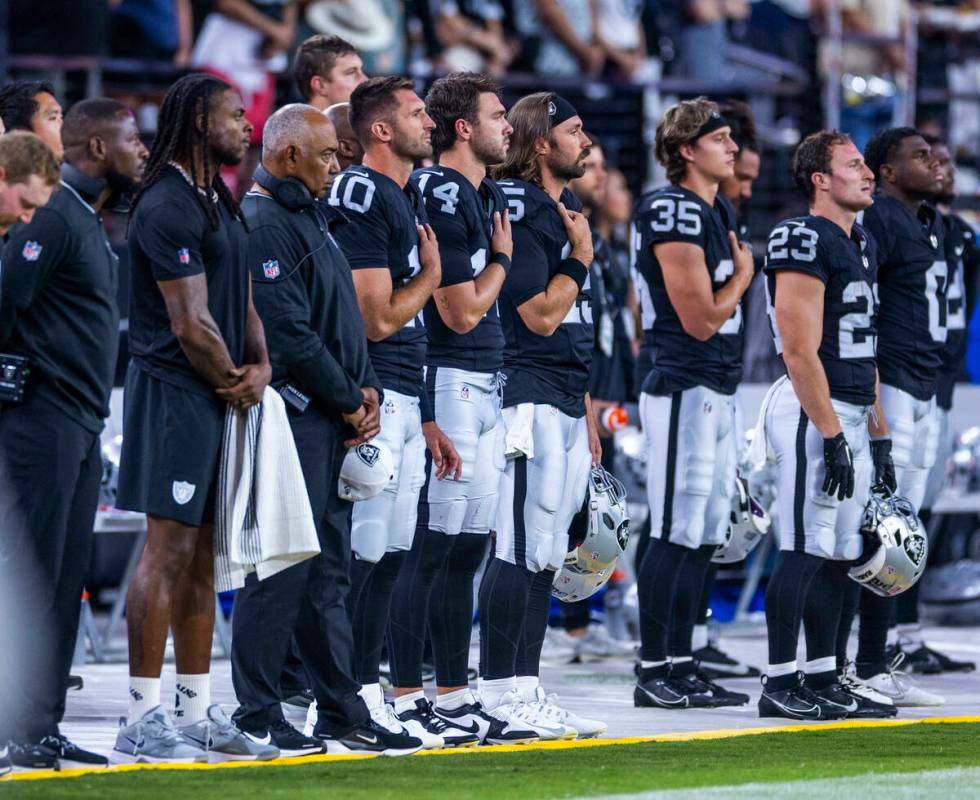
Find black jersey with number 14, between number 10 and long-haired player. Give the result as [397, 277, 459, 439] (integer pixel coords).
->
[411, 166, 507, 372]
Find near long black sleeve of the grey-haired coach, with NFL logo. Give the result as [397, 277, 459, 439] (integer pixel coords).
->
[248, 225, 363, 413]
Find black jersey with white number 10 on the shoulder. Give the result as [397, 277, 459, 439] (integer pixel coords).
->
[329, 166, 427, 398]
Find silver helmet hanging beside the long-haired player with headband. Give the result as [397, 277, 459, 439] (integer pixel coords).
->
[551, 467, 630, 603]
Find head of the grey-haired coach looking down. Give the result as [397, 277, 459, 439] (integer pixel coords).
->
[262, 103, 340, 197]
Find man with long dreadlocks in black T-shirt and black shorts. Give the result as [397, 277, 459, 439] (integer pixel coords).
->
[116, 74, 271, 761]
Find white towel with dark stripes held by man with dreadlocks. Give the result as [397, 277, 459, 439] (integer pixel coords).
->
[214, 387, 320, 592]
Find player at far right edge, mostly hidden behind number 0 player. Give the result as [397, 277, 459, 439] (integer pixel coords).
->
[889, 136, 980, 673]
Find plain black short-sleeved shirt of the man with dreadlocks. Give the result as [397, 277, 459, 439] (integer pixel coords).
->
[129, 167, 249, 397]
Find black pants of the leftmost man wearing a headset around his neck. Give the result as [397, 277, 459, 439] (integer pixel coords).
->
[0, 398, 102, 742]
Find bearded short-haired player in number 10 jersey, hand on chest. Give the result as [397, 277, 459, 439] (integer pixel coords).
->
[329, 77, 459, 736]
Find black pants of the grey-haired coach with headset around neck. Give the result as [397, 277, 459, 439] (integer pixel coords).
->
[231, 408, 368, 730]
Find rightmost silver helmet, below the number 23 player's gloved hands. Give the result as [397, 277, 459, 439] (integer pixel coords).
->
[848, 484, 929, 597]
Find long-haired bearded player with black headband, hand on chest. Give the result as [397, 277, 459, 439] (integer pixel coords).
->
[479, 92, 606, 739]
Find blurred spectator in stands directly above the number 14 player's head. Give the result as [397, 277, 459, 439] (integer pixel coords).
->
[429, 0, 517, 75]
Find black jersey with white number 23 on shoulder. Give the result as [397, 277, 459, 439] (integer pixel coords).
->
[766, 216, 878, 406]
